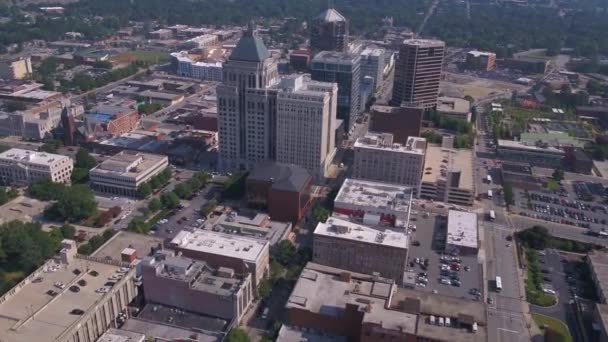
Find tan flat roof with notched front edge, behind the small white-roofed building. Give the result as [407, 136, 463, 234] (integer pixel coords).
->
[422, 145, 473, 190]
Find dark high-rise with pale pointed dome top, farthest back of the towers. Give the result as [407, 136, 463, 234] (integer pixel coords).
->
[310, 6, 348, 53]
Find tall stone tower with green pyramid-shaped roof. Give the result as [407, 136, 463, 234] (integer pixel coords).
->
[217, 24, 278, 170]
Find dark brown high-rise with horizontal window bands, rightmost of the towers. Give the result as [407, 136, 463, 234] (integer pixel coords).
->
[391, 39, 445, 109]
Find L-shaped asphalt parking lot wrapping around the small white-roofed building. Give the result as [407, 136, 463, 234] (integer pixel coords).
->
[408, 213, 482, 299]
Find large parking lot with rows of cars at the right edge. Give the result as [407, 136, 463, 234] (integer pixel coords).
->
[515, 186, 608, 231]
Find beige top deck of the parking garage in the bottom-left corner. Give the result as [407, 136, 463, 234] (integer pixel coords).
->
[0, 258, 128, 342]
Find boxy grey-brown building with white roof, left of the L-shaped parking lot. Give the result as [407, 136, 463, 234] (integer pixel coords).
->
[313, 217, 408, 284]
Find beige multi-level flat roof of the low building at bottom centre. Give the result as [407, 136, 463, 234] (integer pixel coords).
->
[286, 263, 418, 334]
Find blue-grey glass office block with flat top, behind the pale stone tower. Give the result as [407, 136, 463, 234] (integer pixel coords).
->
[310, 51, 363, 132]
